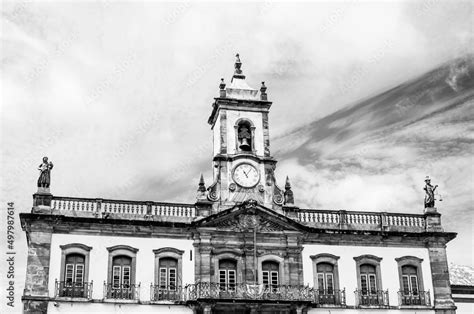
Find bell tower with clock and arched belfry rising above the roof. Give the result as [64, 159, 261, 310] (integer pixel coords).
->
[207, 54, 284, 211]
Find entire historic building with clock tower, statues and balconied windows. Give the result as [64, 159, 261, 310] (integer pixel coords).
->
[21, 56, 456, 314]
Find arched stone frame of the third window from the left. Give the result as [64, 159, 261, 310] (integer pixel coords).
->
[153, 247, 184, 291]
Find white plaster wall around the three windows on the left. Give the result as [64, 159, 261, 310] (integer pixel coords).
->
[49, 234, 195, 301]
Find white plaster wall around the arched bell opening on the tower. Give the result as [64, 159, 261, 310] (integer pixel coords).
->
[227, 110, 264, 155]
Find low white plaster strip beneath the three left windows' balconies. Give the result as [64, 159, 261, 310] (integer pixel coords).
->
[48, 302, 193, 314]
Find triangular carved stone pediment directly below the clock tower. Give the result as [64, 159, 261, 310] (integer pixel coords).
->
[194, 200, 305, 232]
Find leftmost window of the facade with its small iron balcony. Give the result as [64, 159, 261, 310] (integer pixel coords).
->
[55, 243, 92, 298]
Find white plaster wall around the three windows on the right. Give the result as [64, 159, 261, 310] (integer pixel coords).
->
[303, 245, 433, 313]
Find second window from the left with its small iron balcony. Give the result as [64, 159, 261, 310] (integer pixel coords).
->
[104, 245, 140, 300]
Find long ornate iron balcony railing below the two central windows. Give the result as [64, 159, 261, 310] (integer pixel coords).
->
[187, 282, 316, 302]
